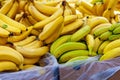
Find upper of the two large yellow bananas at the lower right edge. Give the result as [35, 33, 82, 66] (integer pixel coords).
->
[103, 39, 120, 54]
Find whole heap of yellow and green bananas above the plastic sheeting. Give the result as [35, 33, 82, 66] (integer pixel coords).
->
[0, 0, 120, 72]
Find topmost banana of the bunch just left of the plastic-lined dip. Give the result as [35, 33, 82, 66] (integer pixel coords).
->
[13, 36, 36, 46]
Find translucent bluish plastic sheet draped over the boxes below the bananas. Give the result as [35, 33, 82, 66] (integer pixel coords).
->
[0, 53, 120, 80]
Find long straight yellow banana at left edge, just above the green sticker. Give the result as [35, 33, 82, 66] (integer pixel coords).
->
[0, 13, 26, 31]
